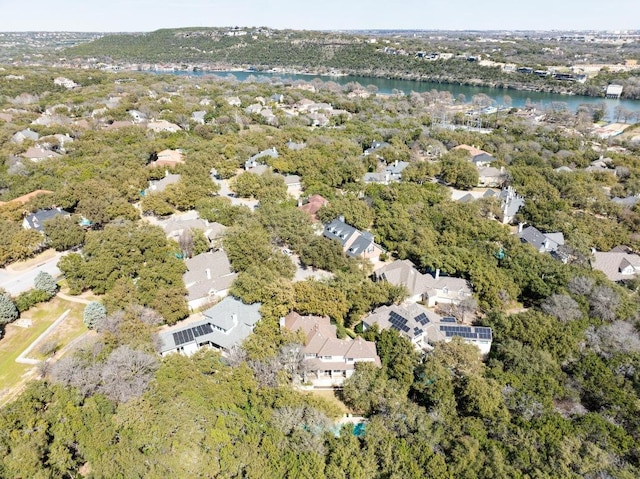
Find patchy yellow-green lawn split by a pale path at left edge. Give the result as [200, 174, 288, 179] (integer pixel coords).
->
[0, 298, 87, 404]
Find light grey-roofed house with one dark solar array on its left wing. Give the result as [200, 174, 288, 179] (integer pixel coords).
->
[158, 296, 261, 356]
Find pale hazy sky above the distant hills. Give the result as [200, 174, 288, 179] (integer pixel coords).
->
[0, 0, 640, 31]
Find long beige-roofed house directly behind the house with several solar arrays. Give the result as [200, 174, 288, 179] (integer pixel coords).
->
[374, 259, 473, 308]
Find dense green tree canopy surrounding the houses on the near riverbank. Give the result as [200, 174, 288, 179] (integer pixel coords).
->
[0, 66, 640, 479]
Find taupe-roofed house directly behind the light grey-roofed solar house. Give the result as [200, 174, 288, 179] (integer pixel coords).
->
[182, 250, 237, 310]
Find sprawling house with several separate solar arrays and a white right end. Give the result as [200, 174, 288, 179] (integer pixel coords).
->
[362, 304, 493, 355]
